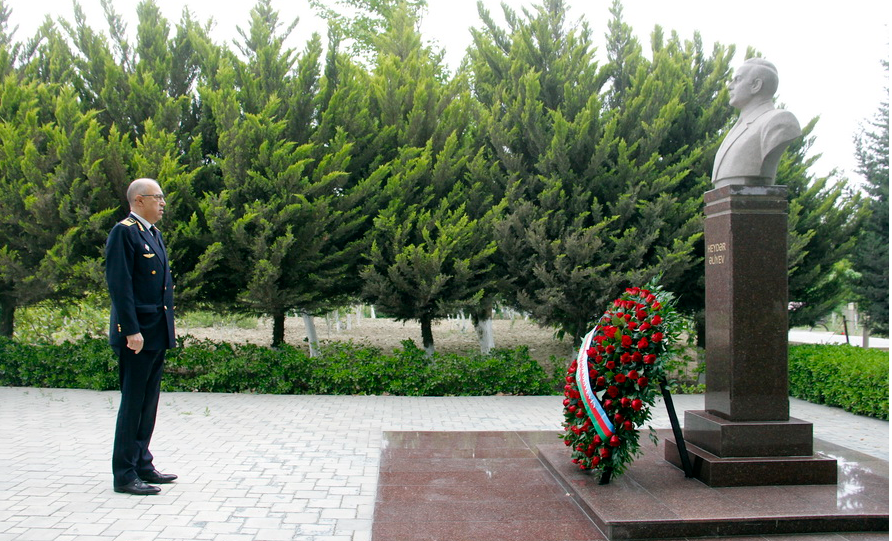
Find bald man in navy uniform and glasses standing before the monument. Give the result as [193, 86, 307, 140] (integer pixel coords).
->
[105, 178, 177, 495]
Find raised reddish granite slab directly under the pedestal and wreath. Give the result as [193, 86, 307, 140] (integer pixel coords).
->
[538, 431, 889, 539]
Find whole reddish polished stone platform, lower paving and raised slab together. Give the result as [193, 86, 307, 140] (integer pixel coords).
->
[372, 430, 889, 541]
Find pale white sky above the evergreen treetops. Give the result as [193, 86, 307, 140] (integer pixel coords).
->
[5, 0, 890, 185]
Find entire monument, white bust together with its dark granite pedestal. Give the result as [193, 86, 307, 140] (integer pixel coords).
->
[665, 58, 836, 486]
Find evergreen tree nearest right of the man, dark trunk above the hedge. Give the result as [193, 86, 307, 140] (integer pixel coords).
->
[192, 0, 380, 345]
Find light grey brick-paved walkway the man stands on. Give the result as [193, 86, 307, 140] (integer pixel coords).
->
[0, 387, 889, 541]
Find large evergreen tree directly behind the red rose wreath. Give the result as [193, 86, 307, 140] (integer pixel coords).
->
[471, 0, 730, 340]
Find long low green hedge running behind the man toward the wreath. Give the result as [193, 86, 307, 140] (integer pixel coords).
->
[0, 337, 558, 396]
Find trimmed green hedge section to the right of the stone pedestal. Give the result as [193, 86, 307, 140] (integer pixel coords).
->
[790, 345, 889, 419]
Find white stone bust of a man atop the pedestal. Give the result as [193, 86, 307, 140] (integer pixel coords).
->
[712, 58, 802, 188]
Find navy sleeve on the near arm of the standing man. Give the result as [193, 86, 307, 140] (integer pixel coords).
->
[105, 225, 139, 336]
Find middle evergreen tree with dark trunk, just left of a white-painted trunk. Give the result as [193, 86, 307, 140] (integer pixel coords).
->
[362, 1, 497, 354]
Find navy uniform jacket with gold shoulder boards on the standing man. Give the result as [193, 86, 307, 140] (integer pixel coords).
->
[105, 215, 176, 351]
